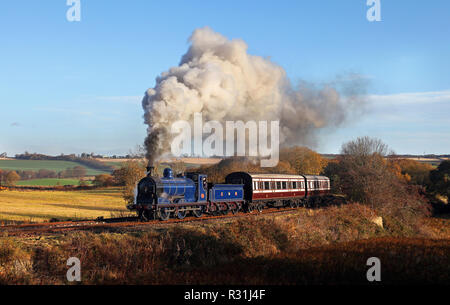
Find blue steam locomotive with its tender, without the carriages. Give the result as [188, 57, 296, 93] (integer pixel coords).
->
[128, 167, 244, 221]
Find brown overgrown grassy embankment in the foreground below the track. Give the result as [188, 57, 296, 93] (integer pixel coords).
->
[0, 204, 450, 285]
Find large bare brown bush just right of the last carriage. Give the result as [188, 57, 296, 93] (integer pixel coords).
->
[325, 137, 429, 224]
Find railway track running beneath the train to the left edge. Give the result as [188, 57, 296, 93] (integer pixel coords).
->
[0, 208, 299, 236]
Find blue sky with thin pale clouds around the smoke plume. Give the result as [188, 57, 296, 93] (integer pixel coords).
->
[0, 0, 450, 155]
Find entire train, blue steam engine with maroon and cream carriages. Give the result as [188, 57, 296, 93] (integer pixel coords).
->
[127, 167, 330, 221]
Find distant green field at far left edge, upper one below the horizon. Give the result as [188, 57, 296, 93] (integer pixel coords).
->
[0, 160, 109, 176]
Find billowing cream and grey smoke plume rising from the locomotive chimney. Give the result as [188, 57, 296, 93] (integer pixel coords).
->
[142, 27, 365, 161]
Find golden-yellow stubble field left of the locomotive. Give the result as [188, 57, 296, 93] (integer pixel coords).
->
[0, 188, 127, 222]
